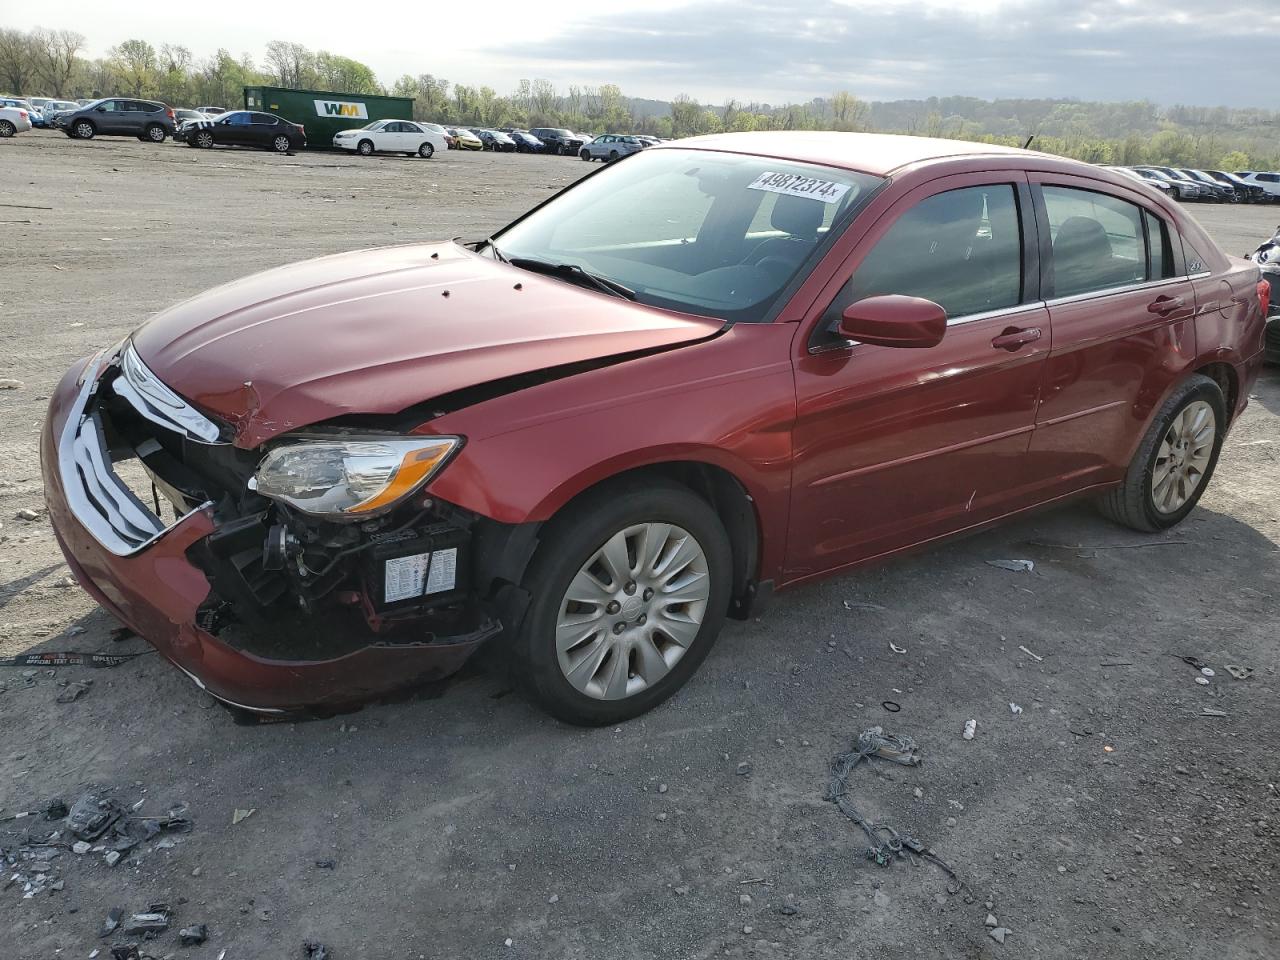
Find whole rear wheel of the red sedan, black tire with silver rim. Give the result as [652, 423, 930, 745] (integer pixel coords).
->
[1098, 374, 1226, 534]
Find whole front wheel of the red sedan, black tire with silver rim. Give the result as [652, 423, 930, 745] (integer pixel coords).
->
[515, 481, 732, 726]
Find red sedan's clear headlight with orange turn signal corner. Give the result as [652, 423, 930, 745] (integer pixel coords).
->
[253, 436, 462, 520]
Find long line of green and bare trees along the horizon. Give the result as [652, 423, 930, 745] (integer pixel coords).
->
[0, 28, 1280, 170]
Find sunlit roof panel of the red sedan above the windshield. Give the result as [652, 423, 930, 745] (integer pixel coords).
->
[659, 131, 1060, 177]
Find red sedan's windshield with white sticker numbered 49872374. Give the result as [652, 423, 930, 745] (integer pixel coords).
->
[495, 148, 882, 323]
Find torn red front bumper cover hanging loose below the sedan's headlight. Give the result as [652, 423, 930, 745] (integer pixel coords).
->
[40, 361, 500, 713]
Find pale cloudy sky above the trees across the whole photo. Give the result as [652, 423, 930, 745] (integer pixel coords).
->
[0, 0, 1280, 109]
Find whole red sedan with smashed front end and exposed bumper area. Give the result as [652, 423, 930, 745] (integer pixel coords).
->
[42, 133, 1268, 723]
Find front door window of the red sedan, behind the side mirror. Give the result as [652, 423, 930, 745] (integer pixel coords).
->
[827, 183, 1023, 320]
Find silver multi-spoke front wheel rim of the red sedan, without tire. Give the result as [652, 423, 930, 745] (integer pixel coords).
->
[556, 524, 710, 700]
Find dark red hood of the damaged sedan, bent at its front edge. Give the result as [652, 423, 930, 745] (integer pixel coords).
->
[133, 243, 723, 448]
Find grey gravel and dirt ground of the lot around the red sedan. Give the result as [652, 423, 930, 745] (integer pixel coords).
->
[0, 133, 1280, 960]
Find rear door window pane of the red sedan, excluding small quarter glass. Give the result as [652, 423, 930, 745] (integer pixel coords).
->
[1042, 186, 1148, 297]
